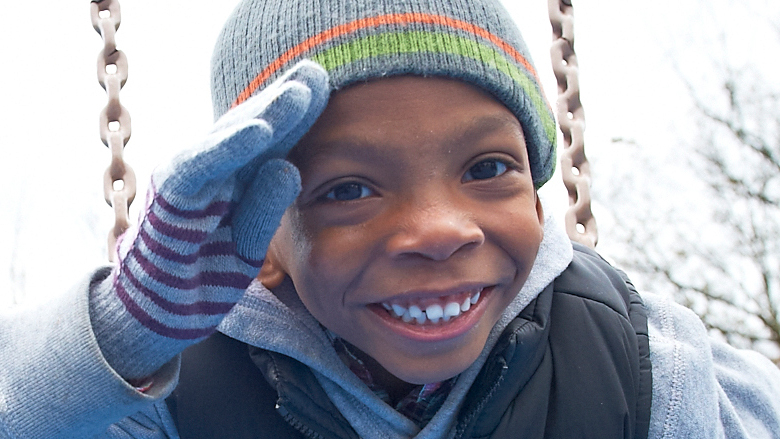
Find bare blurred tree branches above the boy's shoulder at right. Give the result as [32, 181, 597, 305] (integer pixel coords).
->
[604, 72, 780, 364]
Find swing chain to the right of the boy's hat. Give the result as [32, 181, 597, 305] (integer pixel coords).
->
[548, 0, 598, 248]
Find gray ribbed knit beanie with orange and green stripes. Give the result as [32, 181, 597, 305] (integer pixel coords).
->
[211, 0, 556, 187]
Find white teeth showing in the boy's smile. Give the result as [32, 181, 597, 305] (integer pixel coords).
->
[382, 288, 482, 325]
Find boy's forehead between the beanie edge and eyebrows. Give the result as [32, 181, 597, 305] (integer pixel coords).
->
[291, 76, 525, 165]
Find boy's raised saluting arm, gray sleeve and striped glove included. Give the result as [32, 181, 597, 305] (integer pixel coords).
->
[0, 62, 329, 439]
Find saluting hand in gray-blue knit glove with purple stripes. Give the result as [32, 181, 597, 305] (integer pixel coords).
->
[90, 61, 329, 379]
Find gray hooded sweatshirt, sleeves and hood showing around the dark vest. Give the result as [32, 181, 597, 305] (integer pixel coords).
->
[0, 217, 780, 439]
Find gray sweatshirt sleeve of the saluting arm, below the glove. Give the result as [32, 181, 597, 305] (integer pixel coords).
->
[0, 269, 178, 439]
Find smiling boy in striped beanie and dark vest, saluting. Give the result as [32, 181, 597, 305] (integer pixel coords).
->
[0, 0, 780, 438]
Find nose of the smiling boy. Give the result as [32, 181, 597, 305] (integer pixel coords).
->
[387, 200, 485, 261]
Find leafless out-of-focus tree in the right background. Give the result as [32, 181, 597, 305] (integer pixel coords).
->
[595, 1, 780, 365]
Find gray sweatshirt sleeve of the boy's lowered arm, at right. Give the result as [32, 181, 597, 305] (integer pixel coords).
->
[643, 294, 780, 439]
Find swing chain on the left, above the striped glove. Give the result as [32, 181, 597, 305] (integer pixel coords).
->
[90, 0, 136, 262]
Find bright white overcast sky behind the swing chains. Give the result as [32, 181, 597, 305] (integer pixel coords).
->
[0, 0, 777, 306]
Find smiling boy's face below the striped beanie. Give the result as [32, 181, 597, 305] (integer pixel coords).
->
[261, 76, 543, 384]
